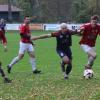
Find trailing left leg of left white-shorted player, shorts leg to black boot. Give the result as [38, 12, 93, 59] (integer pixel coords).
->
[7, 42, 27, 73]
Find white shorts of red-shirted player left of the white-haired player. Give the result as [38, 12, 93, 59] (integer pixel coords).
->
[19, 42, 34, 54]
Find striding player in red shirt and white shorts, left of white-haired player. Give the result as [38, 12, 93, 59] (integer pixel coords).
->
[7, 16, 41, 74]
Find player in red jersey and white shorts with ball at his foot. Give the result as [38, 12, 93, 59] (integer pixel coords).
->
[79, 15, 100, 72]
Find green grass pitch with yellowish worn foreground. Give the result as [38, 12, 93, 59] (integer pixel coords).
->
[0, 31, 100, 100]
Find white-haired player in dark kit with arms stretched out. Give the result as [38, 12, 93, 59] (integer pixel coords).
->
[31, 23, 76, 79]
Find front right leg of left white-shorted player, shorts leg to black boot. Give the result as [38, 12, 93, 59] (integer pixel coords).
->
[28, 44, 41, 74]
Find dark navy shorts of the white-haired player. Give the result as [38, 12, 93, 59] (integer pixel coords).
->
[56, 47, 72, 59]
